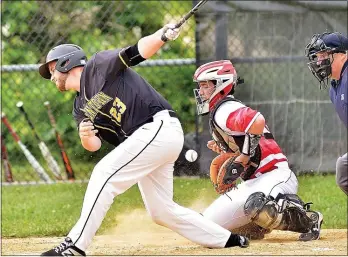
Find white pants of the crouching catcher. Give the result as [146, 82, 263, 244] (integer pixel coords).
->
[203, 162, 298, 230]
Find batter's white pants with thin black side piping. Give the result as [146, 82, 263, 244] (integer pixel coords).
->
[68, 111, 231, 251]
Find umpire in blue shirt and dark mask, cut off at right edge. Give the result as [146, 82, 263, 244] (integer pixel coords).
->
[305, 32, 348, 194]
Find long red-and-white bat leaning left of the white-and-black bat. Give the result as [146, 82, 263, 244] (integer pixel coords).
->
[1, 112, 52, 183]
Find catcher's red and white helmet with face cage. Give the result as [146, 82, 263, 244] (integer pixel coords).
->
[193, 60, 238, 115]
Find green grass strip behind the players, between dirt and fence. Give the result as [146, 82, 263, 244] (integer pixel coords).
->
[1, 175, 347, 237]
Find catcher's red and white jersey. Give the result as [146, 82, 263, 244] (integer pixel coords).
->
[214, 97, 287, 178]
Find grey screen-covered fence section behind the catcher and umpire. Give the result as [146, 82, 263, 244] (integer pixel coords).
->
[196, 1, 347, 173]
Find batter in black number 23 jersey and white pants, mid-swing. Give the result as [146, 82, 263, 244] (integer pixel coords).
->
[39, 25, 248, 256]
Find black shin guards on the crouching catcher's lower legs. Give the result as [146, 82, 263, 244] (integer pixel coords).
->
[244, 192, 320, 233]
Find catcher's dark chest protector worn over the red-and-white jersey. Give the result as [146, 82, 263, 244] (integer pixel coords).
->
[209, 97, 264, 180]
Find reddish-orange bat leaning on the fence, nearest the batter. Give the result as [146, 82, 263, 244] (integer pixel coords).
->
[44, 101, 75, 180]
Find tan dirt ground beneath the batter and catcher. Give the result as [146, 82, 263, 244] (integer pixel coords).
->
[1, 210, 347, 256]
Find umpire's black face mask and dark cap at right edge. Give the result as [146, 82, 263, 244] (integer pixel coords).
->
[305, 32, 348, 88]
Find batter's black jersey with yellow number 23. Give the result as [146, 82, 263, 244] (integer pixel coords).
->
[73, 49, 172, 146]
